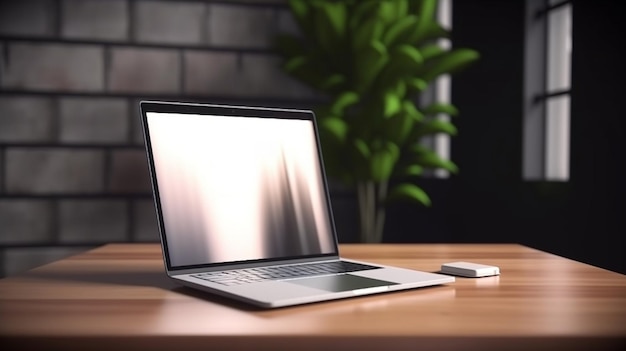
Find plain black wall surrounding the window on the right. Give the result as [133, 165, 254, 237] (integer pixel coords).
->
[366, 0, 626, 273]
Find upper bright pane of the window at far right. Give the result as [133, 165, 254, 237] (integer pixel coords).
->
[547, 4, 572, 92]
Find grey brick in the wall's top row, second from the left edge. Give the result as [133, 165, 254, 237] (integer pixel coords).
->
[61, 0, 129, 40]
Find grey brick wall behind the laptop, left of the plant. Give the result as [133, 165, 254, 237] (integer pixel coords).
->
[0, 0, 314, 276]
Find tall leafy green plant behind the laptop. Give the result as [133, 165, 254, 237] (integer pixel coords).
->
[277, 0, 479, 242]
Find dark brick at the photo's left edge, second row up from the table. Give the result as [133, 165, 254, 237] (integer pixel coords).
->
[0, 199, 54, 244]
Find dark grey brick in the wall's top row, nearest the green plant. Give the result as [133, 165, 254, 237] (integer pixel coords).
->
[208, 4, 276, 48]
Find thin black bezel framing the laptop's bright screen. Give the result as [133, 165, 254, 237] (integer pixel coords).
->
[139, 101, 339, 272]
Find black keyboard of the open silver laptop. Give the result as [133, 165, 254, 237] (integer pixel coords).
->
[192, 261, 380, 286]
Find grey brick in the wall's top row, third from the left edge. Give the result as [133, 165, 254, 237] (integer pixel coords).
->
[134, 1, 206, 44]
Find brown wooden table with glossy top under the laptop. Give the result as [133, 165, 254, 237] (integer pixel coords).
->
[0, 244, 626, 351]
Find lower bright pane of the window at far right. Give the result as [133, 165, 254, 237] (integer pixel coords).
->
[545, 95, 570, 181]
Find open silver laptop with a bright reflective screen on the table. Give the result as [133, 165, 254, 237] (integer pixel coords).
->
[140, 101, 454, 308]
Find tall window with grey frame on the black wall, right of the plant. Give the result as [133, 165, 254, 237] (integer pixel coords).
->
[522, 0, 572, 181]
